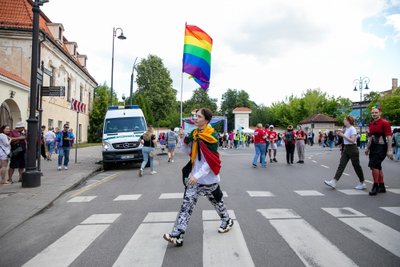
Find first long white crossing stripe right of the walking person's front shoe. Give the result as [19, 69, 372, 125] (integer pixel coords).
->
[258, 209, 357, 266]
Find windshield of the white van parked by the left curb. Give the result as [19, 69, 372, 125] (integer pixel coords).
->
[104, 117, 146, 134]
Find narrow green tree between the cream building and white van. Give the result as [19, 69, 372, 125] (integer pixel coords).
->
[88, 83, 111, 143]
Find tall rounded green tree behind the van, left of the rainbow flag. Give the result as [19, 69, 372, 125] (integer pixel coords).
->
[136, 55, 177, 122]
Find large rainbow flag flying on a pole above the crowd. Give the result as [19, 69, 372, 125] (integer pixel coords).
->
[182, 25, 212, 90]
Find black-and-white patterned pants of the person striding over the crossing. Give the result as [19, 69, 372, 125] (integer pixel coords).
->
[173, 184, 229, 233]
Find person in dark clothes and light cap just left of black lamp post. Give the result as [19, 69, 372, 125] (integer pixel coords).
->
[8, 121, 26, 183]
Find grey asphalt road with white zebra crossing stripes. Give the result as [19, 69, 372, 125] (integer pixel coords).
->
[0, 146, 400, 266]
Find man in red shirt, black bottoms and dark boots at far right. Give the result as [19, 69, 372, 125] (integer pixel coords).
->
[365, 106, 393, 196]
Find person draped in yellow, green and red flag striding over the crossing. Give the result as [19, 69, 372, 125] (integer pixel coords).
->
[163, 108, 233, 246]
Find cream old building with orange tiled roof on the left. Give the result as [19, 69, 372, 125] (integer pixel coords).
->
[0, 0, 97, 142]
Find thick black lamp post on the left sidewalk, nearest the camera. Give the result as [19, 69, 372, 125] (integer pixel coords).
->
[22, 0, 48, 187]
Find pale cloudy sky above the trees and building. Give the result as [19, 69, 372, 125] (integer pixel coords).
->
[41, 0, 400, 105]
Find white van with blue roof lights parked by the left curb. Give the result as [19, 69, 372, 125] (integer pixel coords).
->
[102, 106, 147, 170]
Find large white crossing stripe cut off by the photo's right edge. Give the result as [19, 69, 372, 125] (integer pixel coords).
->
[324, 208, 400, 257]
